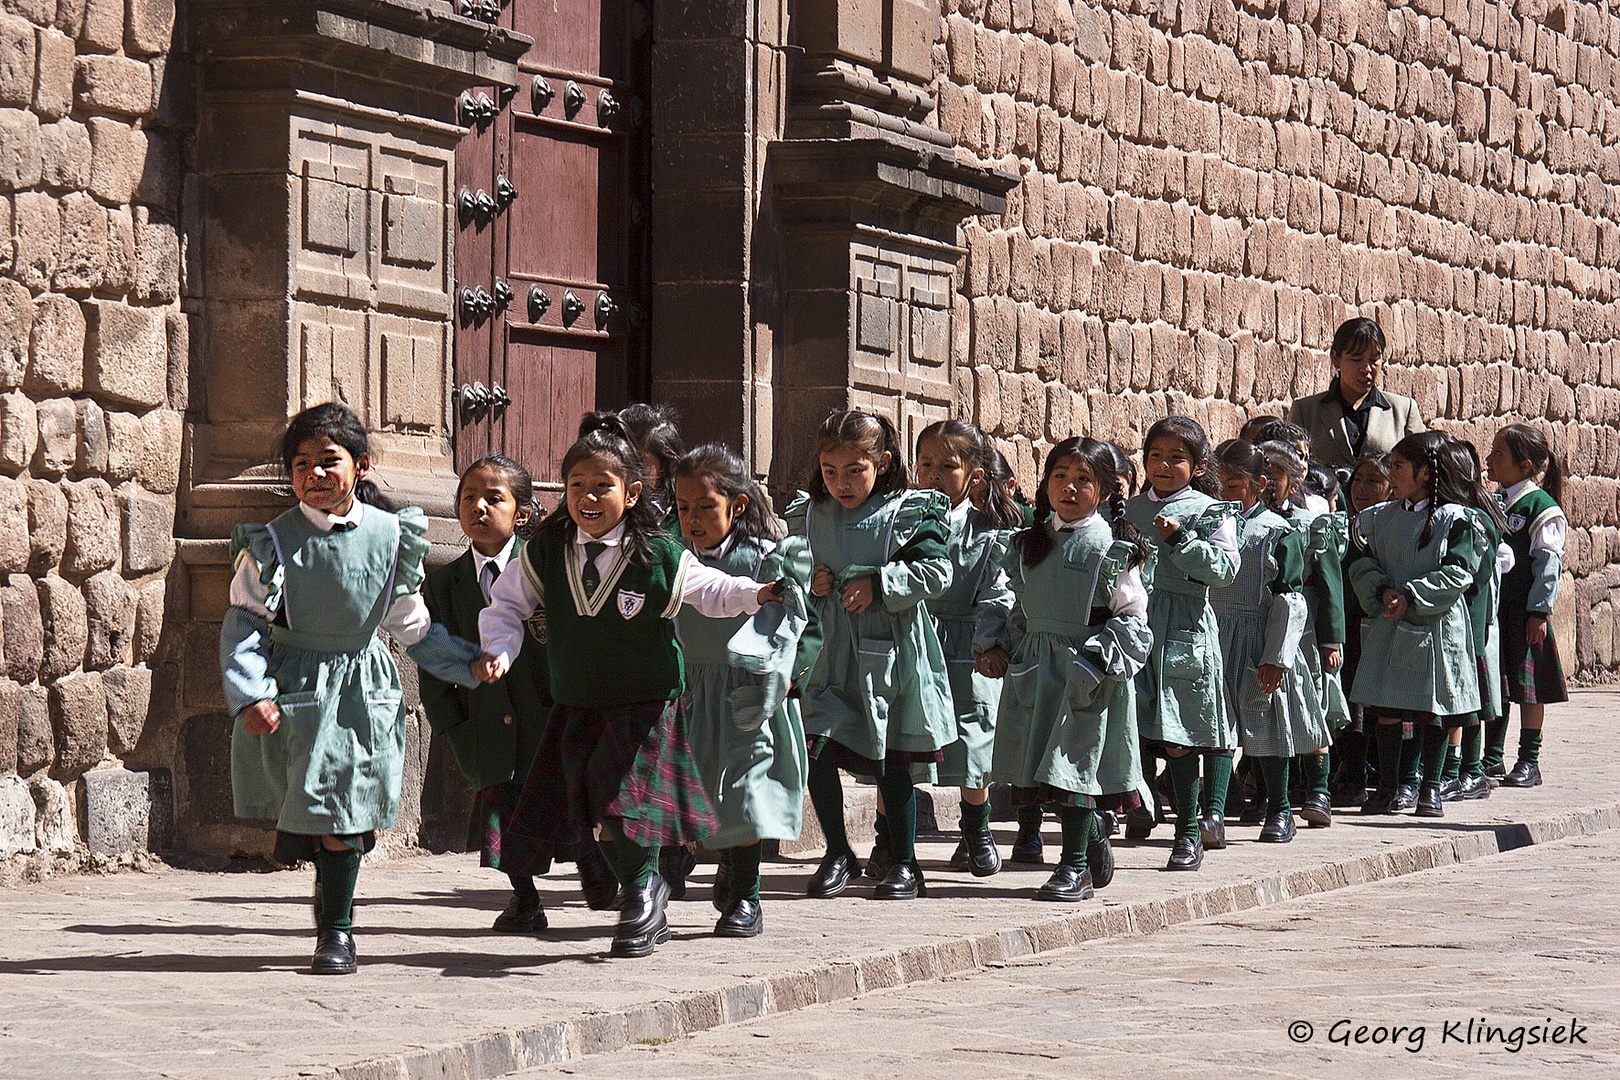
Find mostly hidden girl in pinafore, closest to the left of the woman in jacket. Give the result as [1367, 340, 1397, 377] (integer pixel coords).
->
[1260, 440, 1349, 827]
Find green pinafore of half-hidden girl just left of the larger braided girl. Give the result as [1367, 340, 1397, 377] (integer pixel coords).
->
[928, 502, 1013, 787]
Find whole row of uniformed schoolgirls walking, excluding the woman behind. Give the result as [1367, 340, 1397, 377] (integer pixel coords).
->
[222, 382, 1562, 973]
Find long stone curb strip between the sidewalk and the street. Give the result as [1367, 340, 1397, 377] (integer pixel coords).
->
[296, 805, 1620, 1080]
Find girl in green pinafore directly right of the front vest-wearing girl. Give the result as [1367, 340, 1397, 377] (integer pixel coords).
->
[674, 444, 810, 938]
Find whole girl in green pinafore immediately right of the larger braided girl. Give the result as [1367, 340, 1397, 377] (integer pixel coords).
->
[1126, 416, 1238, 870]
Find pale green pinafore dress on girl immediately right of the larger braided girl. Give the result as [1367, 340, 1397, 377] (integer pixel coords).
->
[1126, 487, 1238, 750]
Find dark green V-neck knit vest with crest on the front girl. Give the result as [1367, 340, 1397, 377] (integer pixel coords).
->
[518, 534, 690, 708]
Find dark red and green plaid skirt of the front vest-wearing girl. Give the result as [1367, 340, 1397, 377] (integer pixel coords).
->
[507, 698, 719, 847]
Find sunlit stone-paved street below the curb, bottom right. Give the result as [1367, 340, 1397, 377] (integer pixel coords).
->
[518, 831, 1620, 1080]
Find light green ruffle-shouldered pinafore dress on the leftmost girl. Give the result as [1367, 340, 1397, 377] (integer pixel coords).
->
[222, 507, 428, 848]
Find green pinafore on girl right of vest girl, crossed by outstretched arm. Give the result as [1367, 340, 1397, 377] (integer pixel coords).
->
[676, 539, 808, 850]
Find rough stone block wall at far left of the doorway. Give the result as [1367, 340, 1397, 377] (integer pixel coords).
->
[0, 0, 190, 855]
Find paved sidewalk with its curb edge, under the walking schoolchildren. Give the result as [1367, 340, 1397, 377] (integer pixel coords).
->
[0, 693, 1620, 1080]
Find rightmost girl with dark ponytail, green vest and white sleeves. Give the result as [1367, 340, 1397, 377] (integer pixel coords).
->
[1484, 424, 1570, 787]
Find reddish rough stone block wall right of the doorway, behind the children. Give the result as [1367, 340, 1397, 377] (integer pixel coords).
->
[935, 0, 1620, 669]
